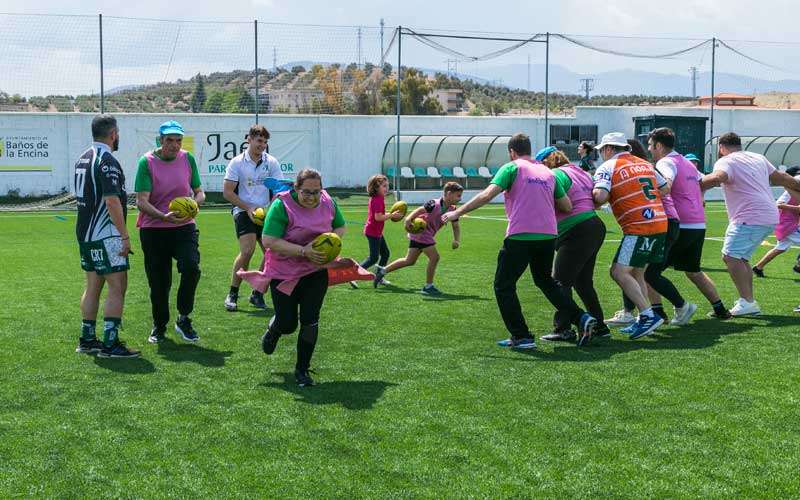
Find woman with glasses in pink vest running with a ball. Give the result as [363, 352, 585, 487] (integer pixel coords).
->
[261, 168, 345, 387]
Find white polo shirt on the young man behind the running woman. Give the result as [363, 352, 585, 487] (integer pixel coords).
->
[225, 148, 283, 215]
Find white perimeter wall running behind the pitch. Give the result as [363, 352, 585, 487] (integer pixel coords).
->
[0, 107, 800, 195]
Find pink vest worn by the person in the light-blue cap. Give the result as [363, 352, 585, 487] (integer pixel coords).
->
[136, 149, 194, 229]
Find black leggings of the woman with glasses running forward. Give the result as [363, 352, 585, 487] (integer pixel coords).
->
[269, 269, 328, 370]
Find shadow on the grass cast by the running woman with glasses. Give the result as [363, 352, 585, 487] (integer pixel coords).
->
[260, 373, 397, 410]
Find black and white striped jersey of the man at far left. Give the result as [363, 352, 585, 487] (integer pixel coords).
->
[73, 144, 128, 241]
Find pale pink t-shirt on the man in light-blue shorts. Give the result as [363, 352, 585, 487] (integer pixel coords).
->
[714, 151, 778, 225]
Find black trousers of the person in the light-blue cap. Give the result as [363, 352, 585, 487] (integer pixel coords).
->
[139, 224, 200, 328]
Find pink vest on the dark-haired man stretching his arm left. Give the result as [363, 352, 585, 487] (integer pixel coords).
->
[505, 158, 558, 237]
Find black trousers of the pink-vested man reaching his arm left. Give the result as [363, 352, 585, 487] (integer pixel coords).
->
[494, 239, 583, 338]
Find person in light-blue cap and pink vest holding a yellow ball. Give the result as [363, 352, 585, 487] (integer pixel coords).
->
[134, 121, 206, 344]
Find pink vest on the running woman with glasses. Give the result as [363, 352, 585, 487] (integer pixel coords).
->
[264, 190, 336, 280]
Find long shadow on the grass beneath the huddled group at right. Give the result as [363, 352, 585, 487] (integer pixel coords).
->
[478, 319, 756, 363]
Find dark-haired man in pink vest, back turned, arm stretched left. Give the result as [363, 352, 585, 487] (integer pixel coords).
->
[442, 133, 597, 349]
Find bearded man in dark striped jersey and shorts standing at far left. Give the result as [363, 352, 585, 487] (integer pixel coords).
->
[74, 115, 139, 358]
